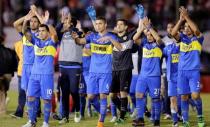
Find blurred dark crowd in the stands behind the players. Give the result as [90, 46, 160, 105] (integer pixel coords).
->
[0, 0, 210, 36]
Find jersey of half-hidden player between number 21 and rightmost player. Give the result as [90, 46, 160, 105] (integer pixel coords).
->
[163, 43, 179, 81]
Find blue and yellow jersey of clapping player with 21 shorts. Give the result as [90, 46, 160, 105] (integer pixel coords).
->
[140, 38, 163, 76]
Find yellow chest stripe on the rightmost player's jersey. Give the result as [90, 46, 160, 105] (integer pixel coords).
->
[180, 41, 202, 52]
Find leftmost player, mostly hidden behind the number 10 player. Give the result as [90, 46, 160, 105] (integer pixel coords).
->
[11, 5, 41, 118]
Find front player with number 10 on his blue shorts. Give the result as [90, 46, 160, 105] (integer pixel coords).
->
[22, 10, 57, 127]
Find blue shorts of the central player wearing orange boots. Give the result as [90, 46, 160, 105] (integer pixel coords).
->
[87, 73, 112, 94]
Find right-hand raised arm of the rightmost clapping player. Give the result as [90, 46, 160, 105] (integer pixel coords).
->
[180, 7, 202, 37]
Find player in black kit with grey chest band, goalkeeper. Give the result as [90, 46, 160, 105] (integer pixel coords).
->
[110, 19, 133, 124]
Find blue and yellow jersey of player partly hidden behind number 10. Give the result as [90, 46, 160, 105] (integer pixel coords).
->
[21, 32, 38, 64]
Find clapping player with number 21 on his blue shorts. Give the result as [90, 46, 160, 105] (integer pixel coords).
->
[133, 17, 162, 127]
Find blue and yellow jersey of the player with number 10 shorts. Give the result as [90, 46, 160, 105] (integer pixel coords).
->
[31, 37, 56, 74]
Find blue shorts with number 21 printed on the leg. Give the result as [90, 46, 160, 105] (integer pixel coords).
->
[136, 76, 161, 98]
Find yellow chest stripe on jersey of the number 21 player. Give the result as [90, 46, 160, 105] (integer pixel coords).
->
[143, 47, 162, 58]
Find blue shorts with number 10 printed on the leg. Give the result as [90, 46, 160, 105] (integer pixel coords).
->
[27, 74, 54, 100]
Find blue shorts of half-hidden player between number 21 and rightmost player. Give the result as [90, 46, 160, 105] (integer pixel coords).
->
[168, 81, 177, 97]
